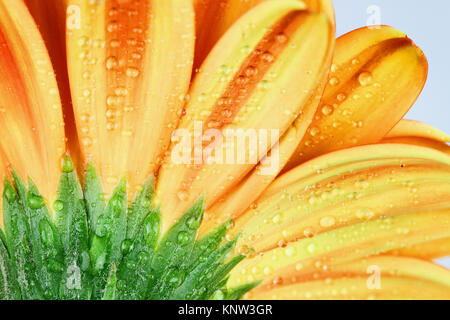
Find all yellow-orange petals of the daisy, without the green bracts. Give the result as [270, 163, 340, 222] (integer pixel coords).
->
[0, 0, 450, 299]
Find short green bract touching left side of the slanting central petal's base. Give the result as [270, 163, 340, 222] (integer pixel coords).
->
[118, 208, 160, 300]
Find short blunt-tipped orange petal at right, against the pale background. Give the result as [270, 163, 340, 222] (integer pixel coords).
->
[285, 27, 428, 171]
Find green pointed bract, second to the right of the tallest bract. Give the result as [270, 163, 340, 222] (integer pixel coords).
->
[90, 179, 127, 299]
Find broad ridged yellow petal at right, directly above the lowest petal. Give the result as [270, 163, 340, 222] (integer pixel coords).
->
[232, 144, 450, 282]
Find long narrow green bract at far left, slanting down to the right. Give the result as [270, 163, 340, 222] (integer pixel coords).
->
[3, 179, 44, 300]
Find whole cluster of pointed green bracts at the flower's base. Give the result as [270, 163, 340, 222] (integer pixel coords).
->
[0, 157, 257, 300]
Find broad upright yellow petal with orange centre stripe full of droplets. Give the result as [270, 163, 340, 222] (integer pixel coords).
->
[67, 0, 195, 200]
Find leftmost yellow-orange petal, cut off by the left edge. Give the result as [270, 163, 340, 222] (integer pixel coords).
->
[0, 0, 65, 202]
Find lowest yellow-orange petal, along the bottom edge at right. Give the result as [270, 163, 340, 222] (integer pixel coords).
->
[245, 256, 450, 300]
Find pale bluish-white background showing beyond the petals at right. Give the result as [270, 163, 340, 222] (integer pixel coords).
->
[333, 0, 450, 268]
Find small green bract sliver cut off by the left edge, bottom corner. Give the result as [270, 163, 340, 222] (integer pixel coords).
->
[0, 229, 21, 300]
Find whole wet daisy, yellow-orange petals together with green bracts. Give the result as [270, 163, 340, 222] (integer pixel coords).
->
[0, 0, 450, 299]
